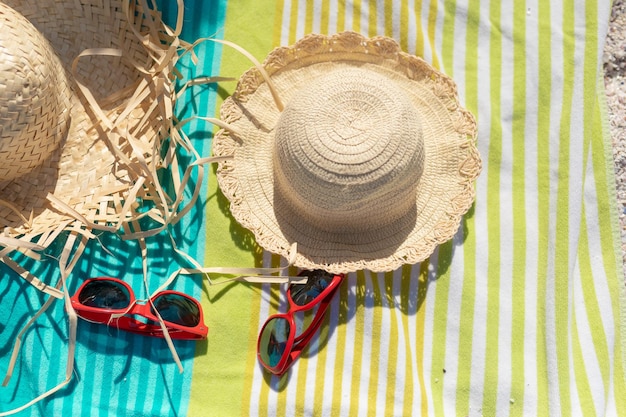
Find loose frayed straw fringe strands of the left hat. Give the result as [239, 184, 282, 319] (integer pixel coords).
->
[0, 0, 306, 416]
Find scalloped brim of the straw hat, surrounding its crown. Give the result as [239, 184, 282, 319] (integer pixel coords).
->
[213, 32, 481, 273]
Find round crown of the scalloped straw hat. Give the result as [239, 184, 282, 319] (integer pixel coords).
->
[273, 68, 424, 233]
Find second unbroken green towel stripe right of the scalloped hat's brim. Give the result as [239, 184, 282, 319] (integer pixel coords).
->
[510, 1, 527, 415]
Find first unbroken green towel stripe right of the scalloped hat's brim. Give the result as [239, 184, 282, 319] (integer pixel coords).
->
[482, 1, 502, 413]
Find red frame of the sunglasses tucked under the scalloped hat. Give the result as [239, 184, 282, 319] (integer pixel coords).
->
[257, 271, 345, 376]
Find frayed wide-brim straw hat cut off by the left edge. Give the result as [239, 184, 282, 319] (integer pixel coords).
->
[0, 0, 195, 290]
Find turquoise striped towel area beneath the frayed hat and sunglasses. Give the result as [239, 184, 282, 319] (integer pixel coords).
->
[0, 0, 226, 416]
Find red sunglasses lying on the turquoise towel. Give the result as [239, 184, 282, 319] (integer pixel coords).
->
[71, 277, 209, 340]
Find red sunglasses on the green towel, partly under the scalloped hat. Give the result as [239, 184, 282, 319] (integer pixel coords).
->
[257, 270, 344, 375]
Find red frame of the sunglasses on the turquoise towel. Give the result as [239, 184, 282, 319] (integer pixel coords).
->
[70, 277, 209, 340]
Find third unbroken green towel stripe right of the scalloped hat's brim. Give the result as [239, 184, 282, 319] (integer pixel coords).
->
[530, 1, 552, 415]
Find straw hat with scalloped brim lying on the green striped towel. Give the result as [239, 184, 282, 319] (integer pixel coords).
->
[213, 32, 481, 273]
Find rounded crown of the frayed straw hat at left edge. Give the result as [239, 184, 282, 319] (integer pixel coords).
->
[0, 3, 70, 181]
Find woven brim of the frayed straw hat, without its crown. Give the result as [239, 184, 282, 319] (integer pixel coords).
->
[0, 0, 158, 240]
